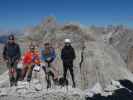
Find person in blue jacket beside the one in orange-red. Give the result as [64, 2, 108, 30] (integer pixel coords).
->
[41, 42, 58, 88]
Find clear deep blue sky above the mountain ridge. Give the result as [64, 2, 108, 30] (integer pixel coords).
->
[0, 0, 133, 29]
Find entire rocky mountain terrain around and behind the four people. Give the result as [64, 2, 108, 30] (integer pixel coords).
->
[0, 17, 133, 100]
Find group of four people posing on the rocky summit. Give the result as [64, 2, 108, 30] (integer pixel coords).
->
[3, 35, 76, 87]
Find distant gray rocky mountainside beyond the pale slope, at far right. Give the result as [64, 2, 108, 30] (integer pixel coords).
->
[102, 27, 133, 63]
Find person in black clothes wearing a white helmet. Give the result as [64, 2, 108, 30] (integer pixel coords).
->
[61, 39, 76, 88]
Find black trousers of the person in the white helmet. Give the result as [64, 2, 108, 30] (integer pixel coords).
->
[63, 61, 75, 84]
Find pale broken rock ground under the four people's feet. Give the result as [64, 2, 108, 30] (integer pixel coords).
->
[0, 80, 84, 100]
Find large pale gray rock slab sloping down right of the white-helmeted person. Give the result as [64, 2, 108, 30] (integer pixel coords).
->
[81, 42, 133, 89]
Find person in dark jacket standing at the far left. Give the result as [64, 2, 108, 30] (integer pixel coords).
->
[3, 35, 21, 86]
